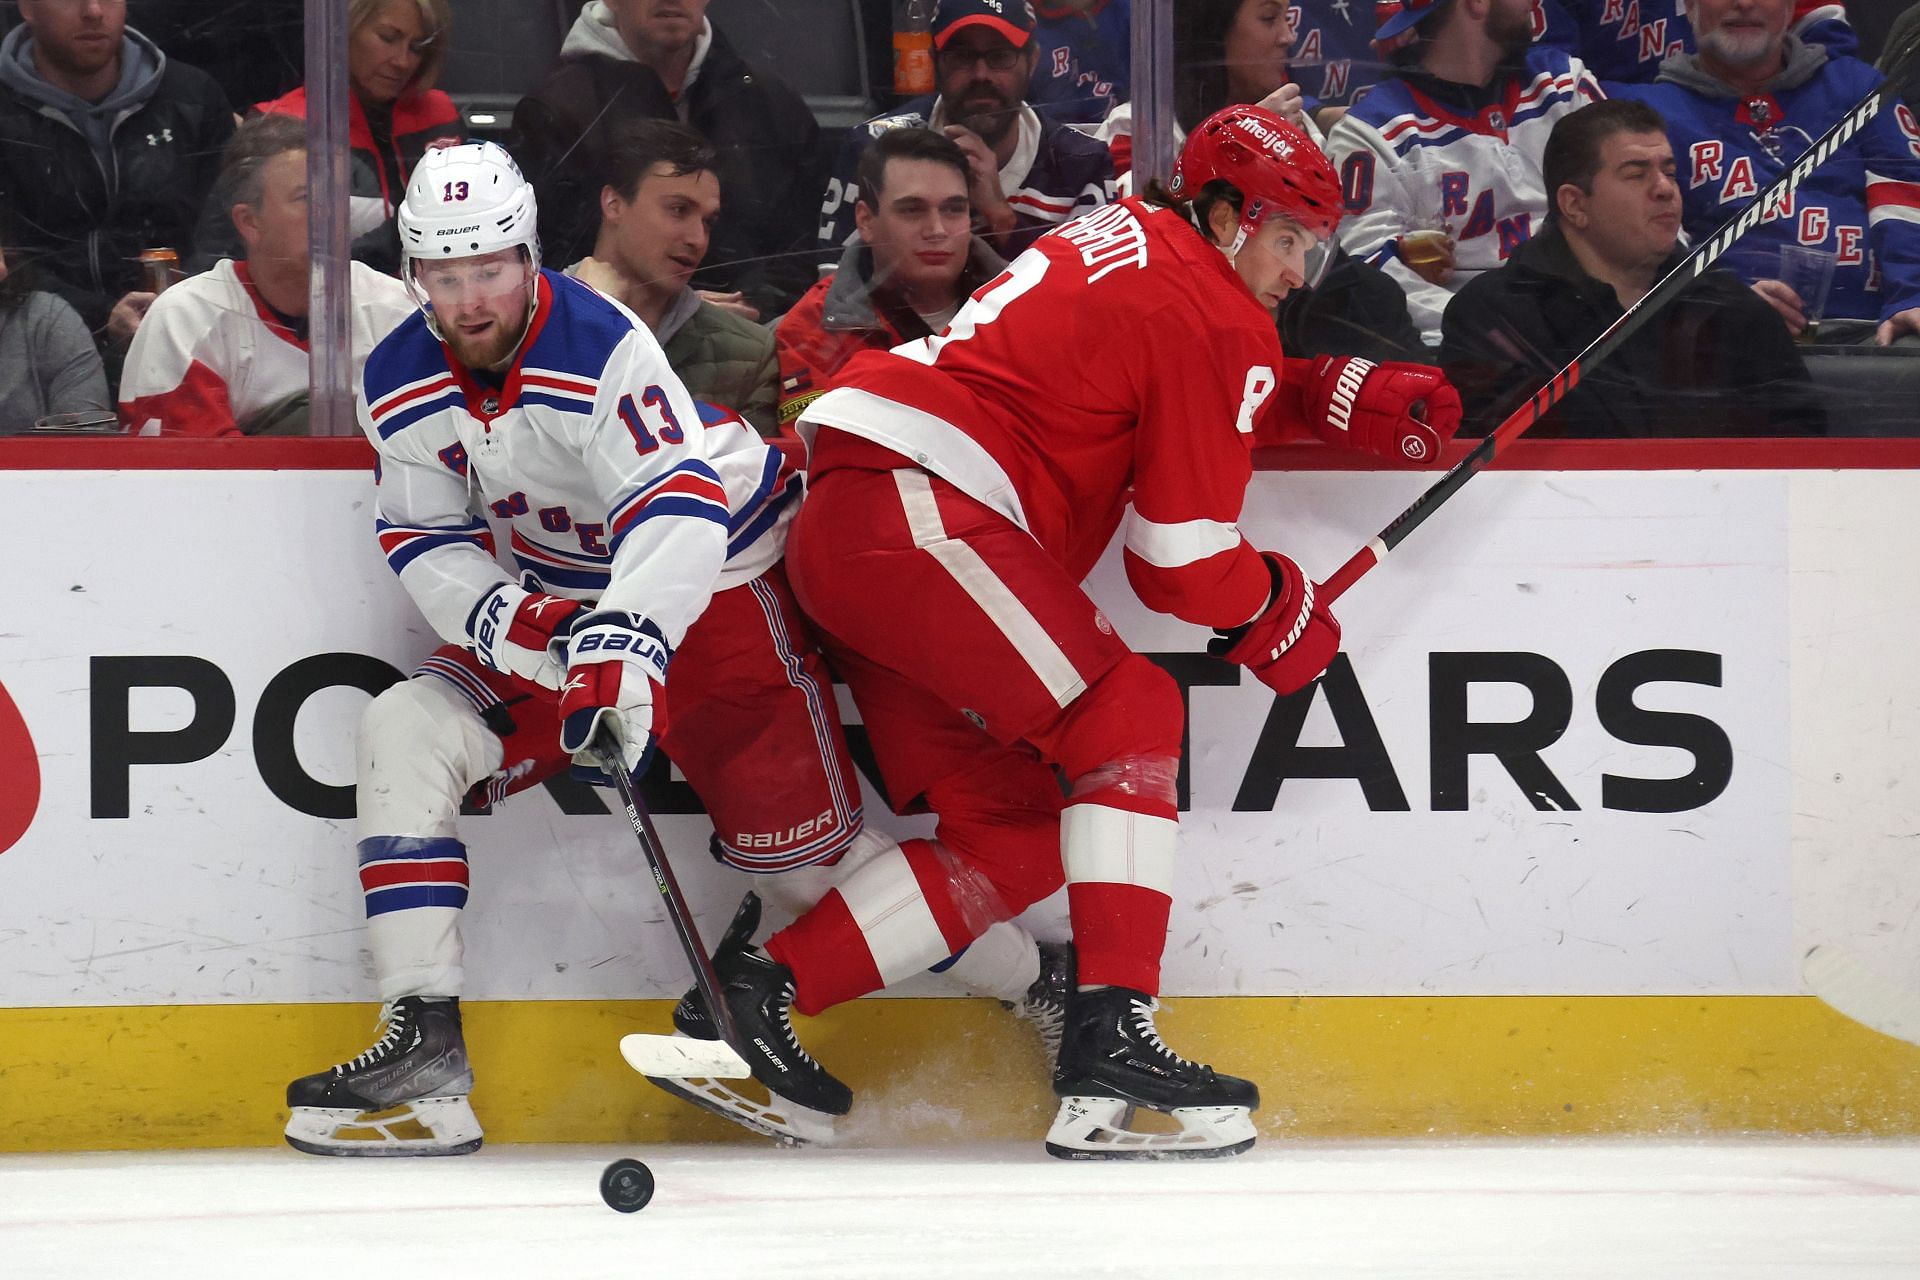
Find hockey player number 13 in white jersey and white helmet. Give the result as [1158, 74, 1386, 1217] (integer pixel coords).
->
[286, 144, 1066, 1155]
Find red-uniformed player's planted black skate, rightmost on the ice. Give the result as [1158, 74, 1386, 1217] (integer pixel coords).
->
[1046, 986, 1260, 1159]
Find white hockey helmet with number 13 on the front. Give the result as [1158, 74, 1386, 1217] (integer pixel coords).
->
[396, 142, 540, 322]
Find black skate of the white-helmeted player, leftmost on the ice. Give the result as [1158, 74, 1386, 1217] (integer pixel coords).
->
[286, 996, 482, 1155]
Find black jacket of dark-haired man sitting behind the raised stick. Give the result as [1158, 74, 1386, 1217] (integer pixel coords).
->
[1440, 223, 1826, 438]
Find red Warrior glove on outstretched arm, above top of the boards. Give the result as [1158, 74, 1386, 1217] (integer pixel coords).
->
[1308, 355, 1459, 462]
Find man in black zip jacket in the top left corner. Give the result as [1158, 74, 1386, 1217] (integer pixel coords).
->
[0, 0, 234, 355]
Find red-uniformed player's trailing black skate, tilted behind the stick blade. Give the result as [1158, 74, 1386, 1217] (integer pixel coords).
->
[647, 894, 852, 1146]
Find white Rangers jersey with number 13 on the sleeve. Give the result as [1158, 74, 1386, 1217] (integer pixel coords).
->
[357, 271, 801, 645]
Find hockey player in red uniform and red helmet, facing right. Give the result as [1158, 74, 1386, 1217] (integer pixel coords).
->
[668, 106, 1459, 1157]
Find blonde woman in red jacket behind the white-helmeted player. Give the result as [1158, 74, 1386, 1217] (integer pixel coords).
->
[255, 0, 465, 274]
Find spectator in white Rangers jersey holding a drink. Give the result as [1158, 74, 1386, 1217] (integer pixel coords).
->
[1327, 0, 1601, 344]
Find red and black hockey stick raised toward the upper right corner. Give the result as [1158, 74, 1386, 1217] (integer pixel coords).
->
[1319, 35, 1920, 604]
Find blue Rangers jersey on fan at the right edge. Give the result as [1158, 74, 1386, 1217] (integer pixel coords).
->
[1611, 45, 1920, 320]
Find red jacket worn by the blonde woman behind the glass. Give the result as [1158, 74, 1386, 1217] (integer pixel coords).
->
[251, 86, 467, 276]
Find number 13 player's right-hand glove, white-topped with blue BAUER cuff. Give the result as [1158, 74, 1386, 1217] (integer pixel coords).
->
[561, 608, 668, 773]
